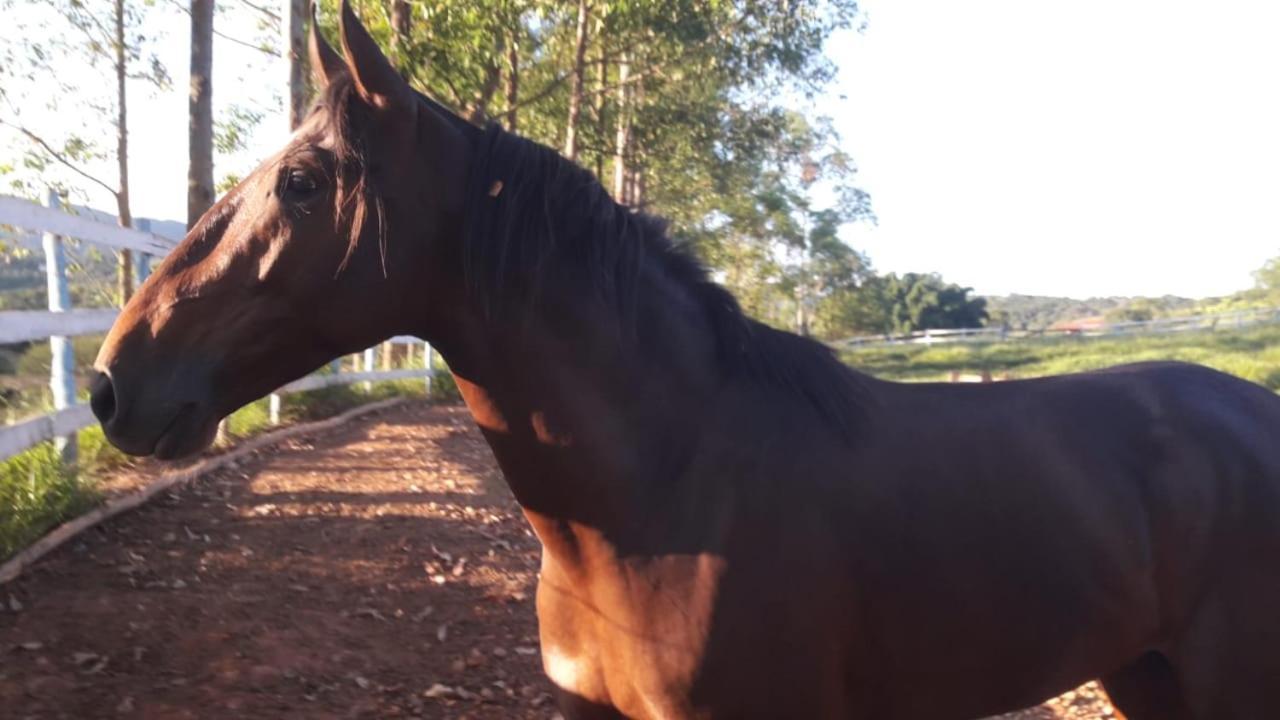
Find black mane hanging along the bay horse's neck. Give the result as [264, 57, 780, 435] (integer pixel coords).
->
[463, 126, 867, 433]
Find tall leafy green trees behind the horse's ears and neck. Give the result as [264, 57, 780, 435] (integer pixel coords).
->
[321, 0, 872, 336]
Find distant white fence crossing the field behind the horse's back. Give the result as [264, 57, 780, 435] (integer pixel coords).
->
[832, 307, 1280, 348]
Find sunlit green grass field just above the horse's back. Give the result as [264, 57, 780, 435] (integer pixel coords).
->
[841, 319, 1280, 391]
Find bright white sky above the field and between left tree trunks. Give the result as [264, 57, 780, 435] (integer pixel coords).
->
[10, 0, 1280, 297]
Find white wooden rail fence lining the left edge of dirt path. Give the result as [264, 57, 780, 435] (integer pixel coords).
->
[0, 191, 434, 461]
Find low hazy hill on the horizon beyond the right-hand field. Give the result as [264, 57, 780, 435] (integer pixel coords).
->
[986, 295, 1204, 329]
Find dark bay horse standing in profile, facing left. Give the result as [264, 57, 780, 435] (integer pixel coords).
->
[92, 4, 1280, 720]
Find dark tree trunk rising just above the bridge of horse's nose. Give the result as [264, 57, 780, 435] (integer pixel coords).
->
[187, 0, 214, 229]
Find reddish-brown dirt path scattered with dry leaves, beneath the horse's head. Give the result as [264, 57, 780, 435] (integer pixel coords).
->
[0, 404, 1111, 720]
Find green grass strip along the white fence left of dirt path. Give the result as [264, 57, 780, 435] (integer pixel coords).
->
[0, 373, 458, 561]
